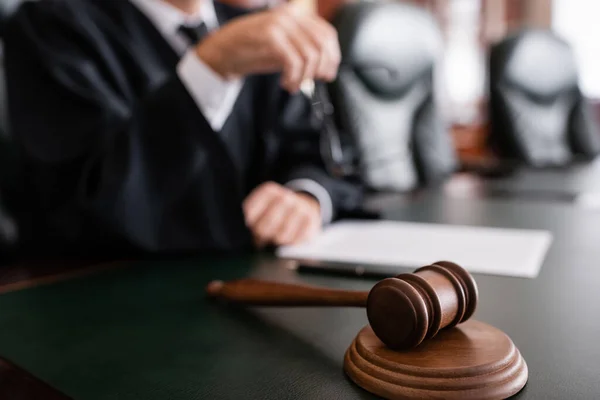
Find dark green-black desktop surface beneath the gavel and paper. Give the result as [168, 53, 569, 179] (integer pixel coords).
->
[0, 196, 600, 400]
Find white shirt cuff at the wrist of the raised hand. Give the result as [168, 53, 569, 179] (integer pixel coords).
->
[177, 50, 243, 132]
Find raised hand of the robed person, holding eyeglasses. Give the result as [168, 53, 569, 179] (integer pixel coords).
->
[196, 4, 341, 92]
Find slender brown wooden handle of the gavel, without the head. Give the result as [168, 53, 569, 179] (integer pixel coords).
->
[206, 279, 369, 307]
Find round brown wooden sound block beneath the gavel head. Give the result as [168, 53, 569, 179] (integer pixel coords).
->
[344, 321, 528, 400]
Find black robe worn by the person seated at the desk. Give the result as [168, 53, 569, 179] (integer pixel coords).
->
[5, 0, 360, 254]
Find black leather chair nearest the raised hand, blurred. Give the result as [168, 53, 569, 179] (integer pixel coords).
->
[330, 2, 457, 191]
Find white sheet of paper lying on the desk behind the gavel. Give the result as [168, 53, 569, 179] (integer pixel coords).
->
[277, 221, 552, 278]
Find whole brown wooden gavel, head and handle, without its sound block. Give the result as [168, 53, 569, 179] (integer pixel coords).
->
[206, 261, 478, 350]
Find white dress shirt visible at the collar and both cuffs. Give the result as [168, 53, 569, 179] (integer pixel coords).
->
[130, 0, 333, 223]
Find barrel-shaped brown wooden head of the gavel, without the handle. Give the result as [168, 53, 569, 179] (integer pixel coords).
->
[367, 261, 478, 350]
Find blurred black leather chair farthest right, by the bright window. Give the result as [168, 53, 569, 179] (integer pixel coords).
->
[489, 30, 600, 167]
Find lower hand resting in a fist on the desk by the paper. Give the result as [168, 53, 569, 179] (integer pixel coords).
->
[243, 182, 321, 247]
